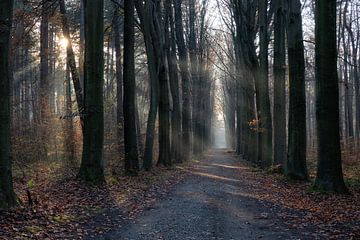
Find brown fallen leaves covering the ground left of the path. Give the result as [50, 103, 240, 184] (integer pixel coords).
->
[0, 164, 185, 239]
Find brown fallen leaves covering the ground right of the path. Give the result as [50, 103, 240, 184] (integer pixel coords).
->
[231, 153, 360, 239]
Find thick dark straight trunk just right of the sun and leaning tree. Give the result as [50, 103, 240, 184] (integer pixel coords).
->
[78, 0, 105, 184]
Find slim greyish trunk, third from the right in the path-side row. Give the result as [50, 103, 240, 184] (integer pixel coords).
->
[273, 0, 286, 166]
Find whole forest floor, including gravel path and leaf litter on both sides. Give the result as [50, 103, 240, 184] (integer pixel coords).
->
[0, 150, 360, 240]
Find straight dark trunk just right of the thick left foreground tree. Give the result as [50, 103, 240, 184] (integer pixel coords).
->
[123, 0, 139, 175]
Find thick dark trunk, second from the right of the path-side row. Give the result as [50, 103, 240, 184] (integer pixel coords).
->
[286, 0, 308, 180]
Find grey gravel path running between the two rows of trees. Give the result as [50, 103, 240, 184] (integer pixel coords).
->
[97, 149, 305, 240]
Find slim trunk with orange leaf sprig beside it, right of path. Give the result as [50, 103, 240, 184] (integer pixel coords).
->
[257, 1, 273, 167]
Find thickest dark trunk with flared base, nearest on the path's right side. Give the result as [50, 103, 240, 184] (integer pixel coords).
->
[315, 0, 348, 193]
